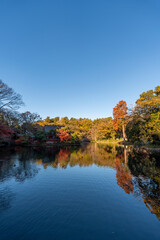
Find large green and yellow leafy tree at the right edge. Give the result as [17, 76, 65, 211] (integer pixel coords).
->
[126, 86, 160, 144]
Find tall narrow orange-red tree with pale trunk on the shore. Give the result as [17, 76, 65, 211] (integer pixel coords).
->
[113, 100, 128, 140]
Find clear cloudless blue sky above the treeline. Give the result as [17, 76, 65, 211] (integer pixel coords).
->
[0, 0, 160, 119]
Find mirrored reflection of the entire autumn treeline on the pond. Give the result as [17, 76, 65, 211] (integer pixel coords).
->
[0, 144, 160, 220]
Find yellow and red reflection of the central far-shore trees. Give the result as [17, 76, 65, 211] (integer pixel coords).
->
[32, 144, 119, 168]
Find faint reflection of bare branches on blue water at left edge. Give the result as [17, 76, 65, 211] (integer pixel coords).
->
[0, 187, 15, 214]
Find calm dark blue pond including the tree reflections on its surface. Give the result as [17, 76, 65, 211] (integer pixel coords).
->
[0, 144, 160, 240]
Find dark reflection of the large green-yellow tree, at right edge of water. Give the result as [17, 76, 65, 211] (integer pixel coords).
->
[128, 150, 160, 220]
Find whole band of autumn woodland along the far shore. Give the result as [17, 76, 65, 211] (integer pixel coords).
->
[0, 80, 160, 145]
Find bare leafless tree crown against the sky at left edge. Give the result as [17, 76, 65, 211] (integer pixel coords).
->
[0, 80, 24, 111]
